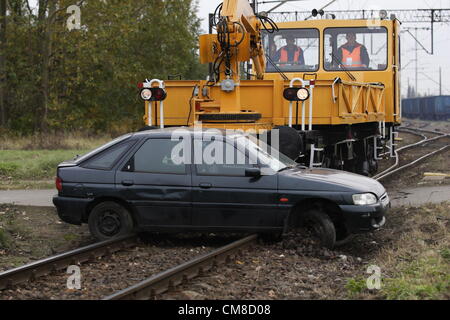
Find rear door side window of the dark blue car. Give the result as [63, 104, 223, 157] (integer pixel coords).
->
[127, 139, 186, 174]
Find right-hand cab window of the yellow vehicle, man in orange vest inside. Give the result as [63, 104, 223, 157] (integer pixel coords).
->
[324, 27, 388, 71]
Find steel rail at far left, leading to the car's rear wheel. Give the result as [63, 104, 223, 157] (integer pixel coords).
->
[0, 235, 137, 291]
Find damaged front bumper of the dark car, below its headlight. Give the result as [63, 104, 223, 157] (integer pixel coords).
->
[340, 197, 391, 233]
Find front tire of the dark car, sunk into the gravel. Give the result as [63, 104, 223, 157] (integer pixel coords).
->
[302, 209, 336, 250]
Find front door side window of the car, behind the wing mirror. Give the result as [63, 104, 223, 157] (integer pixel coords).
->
[196, 141, 255, 177]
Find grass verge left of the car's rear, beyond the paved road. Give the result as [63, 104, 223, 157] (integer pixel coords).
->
[0, 134, 110, 190]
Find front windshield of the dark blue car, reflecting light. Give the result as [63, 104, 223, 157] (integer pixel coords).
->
[234, 135, 298, 174]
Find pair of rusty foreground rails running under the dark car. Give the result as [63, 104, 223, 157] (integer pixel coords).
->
[0, 235, 258, 300]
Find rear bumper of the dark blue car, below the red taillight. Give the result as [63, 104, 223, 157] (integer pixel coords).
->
[53, 196, 92, 225]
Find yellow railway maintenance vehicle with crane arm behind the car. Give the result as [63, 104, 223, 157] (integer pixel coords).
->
[141, 0, 401, 175]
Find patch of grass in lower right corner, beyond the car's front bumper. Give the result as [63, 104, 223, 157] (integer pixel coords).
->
[346, 203, 450, 300]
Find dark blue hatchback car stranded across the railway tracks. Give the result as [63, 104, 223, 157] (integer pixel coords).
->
[53, 128, 389, 248]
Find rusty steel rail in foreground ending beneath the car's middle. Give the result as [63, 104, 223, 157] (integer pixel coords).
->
[103, 235, 258, 300]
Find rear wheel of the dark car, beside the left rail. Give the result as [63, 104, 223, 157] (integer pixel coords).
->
[88, 201, 134, 241]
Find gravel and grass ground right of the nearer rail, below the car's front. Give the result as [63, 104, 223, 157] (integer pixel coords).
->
[159, 203, 450, 300]
